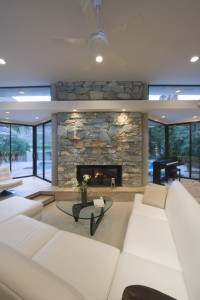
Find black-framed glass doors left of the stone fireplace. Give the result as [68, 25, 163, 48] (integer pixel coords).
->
[0, 122, 52, 181]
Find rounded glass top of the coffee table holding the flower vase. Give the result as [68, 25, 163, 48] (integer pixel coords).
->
[56, 196, 113, 219]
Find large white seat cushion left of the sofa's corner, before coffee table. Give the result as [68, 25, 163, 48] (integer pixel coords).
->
[33, 231, 120, 300]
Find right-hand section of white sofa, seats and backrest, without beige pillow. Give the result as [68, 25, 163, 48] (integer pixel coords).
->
[109, 181, 200, 300]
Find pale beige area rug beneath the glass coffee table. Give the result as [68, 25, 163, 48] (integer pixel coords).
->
[42, 201, 133, 250]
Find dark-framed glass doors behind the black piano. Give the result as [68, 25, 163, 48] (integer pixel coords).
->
[149, 121, 200, 180]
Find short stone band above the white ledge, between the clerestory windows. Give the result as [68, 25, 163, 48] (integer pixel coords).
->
[56, 81, 142, 101]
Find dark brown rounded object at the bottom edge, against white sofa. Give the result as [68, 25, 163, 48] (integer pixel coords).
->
[122, 285, 176, 300]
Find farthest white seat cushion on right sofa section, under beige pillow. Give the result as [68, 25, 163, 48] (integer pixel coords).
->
[132, 194, 168, 221]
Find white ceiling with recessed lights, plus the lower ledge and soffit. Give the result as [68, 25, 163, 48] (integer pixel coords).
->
[0, 0, 200, 124]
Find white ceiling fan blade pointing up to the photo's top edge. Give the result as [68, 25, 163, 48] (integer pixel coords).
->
[78, 0, 97, 32]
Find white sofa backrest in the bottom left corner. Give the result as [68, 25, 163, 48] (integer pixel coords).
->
[0, 242, 86, 300]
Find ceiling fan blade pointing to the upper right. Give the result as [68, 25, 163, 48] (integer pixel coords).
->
[109, 15, 143, 37]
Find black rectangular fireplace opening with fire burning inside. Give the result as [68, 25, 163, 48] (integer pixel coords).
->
[77, 165, 122, 186]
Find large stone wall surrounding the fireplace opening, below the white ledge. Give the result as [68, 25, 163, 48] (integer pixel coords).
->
[57, 112, 142, 187]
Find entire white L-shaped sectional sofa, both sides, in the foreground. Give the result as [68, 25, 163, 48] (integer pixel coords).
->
[0, 181, 200, 300]
